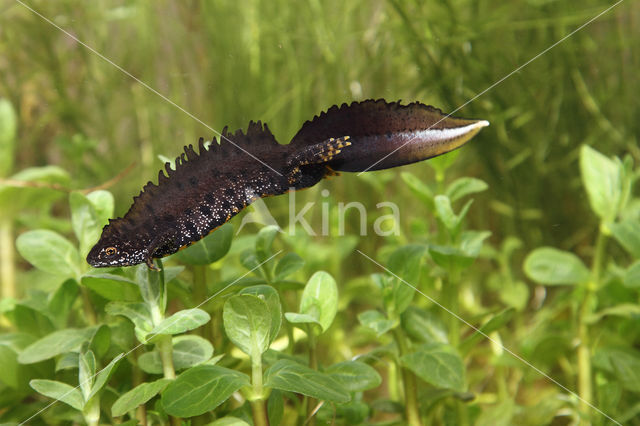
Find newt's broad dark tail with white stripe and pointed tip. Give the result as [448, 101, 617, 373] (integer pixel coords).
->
[291, 99, 489, 172]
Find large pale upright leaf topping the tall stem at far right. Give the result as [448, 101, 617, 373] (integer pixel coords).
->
[580, 145, 623, 222]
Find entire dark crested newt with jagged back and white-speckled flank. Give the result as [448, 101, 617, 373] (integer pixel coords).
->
[87, 100, 489, 267]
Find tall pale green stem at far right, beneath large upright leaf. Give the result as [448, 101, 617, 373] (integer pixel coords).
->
[578, 225, 607, 424]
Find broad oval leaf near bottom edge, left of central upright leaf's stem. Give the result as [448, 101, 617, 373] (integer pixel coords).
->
[162, 364, 250, 417]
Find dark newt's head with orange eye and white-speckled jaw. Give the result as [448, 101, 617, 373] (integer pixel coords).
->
[87, 219, 147, 268]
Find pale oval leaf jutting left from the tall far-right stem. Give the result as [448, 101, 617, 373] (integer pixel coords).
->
[524, 247, 589, 285]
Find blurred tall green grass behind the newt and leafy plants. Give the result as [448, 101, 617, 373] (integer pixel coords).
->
[0, 0, 640, 424]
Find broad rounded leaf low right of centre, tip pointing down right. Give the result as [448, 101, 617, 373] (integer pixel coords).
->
[401, 343, 464, 392]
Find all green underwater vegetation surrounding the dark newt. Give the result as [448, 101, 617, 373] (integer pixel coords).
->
[0, 0, 640, 425]
